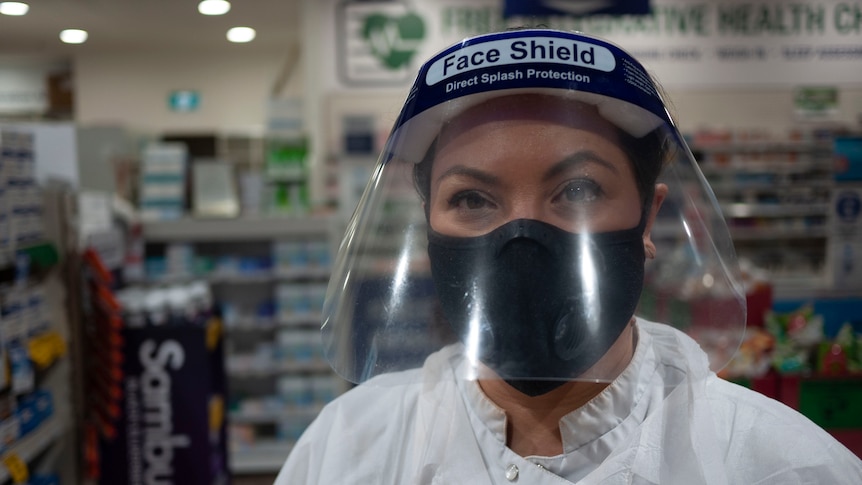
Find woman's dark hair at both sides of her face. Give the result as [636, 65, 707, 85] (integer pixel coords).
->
[413, 127, 670, 220]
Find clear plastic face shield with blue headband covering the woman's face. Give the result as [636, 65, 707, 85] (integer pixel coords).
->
[322, 30, 745, 394]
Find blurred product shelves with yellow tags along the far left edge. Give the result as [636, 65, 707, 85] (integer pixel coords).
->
[0, 127, 77, 484]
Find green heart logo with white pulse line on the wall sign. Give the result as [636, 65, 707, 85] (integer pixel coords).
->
[362, 12, 425, 70]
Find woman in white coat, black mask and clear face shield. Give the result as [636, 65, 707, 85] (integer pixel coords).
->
[277, 30, 862, 484]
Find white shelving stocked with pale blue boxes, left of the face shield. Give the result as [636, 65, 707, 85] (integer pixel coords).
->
[143, 216, 346, 475]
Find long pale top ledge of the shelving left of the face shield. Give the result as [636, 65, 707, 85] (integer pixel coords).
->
[143, 217, 334, 243]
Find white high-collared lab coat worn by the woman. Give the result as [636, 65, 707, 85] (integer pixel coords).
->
[276, 319, 862, 485]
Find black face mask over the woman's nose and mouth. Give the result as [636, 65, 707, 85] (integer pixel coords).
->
[428, 218, 645, 396]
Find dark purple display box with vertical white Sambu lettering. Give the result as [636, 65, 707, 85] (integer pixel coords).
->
[99, 323, 229, 485]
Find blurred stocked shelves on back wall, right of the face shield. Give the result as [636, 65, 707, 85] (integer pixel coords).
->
[692, 134, 834, 294]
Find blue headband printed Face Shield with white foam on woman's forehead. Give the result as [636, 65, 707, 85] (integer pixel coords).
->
[390, 30, 673, 163]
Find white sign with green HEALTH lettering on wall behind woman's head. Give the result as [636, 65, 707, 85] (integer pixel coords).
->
[328, 0, 862, 89]
